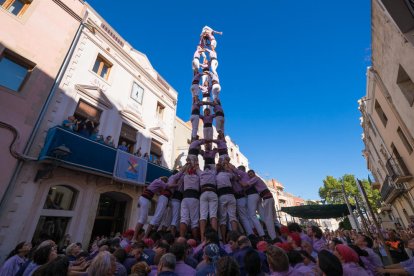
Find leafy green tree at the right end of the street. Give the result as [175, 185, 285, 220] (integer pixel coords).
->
[319, 174, 381, 212]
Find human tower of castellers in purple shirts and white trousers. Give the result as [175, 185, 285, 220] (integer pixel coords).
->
[134, 26, 276, 240]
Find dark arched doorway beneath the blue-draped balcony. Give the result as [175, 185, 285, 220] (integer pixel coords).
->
[91, 192, 132, 240]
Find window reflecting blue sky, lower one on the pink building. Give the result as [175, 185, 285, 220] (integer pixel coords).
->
[0, 49, 35, 92]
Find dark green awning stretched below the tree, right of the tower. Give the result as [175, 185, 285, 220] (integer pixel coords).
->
[281, 204, 355, 219]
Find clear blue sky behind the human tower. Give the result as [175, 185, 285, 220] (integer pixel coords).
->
[88, 0, 371, 199]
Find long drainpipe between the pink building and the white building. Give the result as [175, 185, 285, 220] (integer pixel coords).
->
[0, 11, 88, 218]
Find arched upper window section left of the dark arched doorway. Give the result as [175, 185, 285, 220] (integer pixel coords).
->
[43, 186, 77, 210]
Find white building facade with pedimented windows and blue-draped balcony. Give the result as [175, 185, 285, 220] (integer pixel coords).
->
[0, 4, 177, 256]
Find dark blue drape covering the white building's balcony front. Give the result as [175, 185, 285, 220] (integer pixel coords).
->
[38, 126, 172, 184]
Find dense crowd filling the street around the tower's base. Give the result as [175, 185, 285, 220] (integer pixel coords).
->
[0, 223, 414, 276]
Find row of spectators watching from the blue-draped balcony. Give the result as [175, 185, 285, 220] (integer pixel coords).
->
[62, 115, 162, 166]
